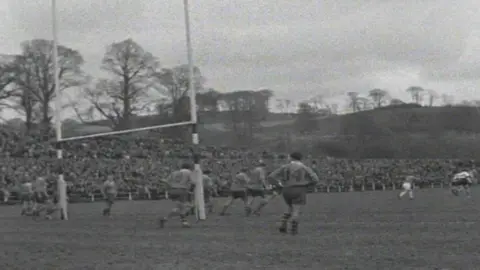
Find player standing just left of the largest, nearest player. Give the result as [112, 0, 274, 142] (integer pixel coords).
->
[247, 161, 268, 215]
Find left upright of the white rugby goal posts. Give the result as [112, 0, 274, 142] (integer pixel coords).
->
[51, 0, 68, 220]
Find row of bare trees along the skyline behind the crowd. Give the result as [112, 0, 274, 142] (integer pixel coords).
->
[0, 39, 480, 146]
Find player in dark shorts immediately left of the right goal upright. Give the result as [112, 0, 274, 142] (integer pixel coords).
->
[159, 164, 195, 228]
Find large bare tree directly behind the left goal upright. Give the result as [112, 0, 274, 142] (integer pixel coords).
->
[14, 39, 85, 133]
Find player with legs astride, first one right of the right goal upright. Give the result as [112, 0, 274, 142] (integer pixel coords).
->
[220, 168, 250, 216]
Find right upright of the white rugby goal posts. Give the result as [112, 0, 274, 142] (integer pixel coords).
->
[183, 0, 206, 220]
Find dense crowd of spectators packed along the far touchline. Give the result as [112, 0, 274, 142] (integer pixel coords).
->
[0, 129, 475, 200]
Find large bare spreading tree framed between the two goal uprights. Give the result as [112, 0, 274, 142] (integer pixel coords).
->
[81, 39, 159, 130]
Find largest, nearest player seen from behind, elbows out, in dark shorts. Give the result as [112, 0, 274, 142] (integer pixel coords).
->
[268, 152, 319, 235]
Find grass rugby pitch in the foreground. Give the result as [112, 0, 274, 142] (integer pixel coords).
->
[0, 189, 480, 270]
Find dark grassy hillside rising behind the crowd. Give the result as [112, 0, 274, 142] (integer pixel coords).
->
[68, 104, 480, 158]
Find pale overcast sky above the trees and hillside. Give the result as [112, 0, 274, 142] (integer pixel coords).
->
[0, 0, 480, 110]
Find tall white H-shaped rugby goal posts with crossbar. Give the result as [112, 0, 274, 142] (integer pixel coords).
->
[51, 0, 206, 220]
